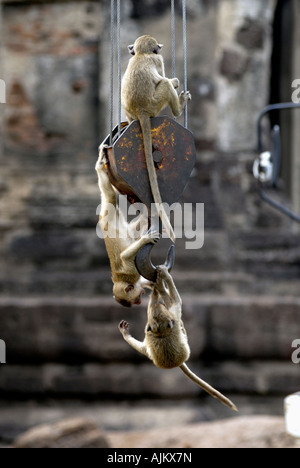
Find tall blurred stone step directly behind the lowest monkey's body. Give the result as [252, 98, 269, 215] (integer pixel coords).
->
[0, 294, 300, 365]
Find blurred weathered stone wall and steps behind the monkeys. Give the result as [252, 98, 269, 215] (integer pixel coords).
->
[0, 0, 300, 444]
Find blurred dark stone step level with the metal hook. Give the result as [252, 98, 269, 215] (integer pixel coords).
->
[4, 229, 300, 280]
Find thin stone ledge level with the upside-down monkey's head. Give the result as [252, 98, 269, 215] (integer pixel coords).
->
[0, 266, 299, 297]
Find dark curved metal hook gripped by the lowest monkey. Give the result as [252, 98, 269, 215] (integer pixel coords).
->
[135, 244, 175, 283]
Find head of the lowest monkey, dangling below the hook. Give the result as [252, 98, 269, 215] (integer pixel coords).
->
[146, 303, 175, 337]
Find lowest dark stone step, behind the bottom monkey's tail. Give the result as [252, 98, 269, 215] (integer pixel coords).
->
[0, 361, 299, 401]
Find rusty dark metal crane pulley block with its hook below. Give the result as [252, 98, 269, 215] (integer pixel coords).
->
[104, 117, 196, 281]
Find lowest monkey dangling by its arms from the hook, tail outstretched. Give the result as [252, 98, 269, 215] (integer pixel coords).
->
[119, 266, 238, 411]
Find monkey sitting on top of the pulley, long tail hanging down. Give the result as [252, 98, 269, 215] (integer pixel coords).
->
[121, 36, 191, 243]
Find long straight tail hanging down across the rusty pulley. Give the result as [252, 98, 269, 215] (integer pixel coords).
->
[139, 115, 176, 244]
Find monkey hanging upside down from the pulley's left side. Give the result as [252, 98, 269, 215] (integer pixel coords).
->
[96, 144, 160, 307]
